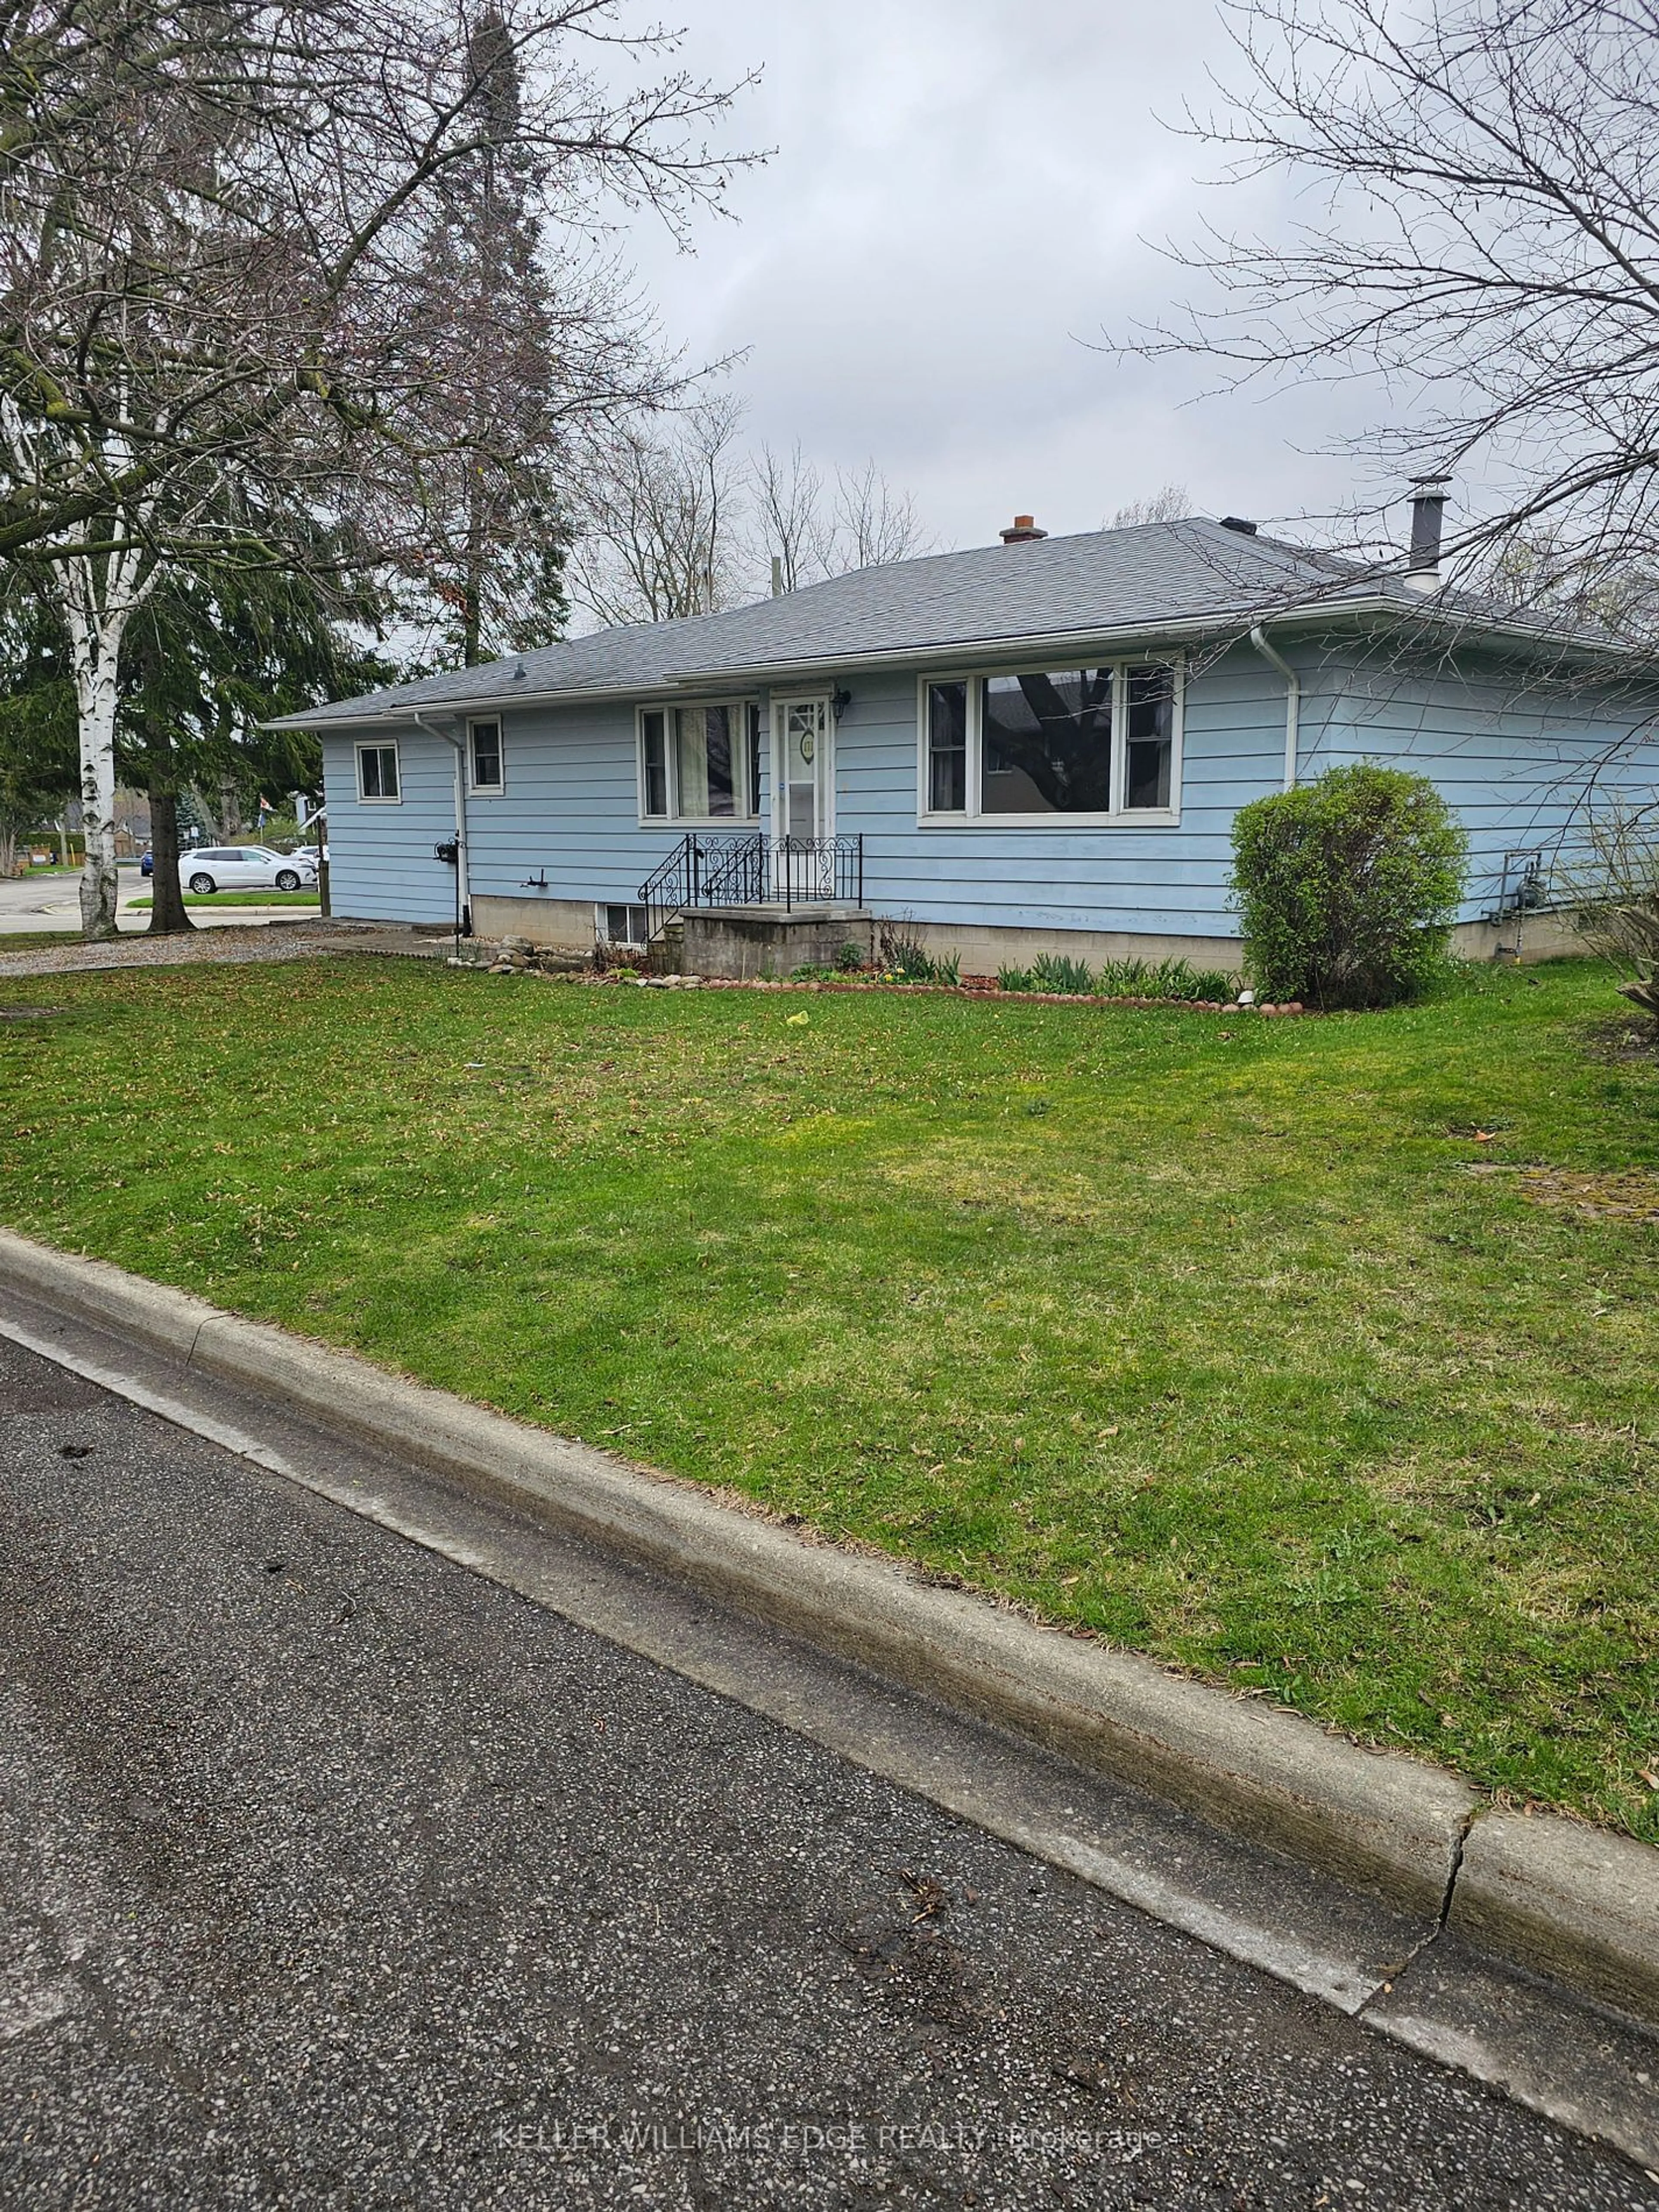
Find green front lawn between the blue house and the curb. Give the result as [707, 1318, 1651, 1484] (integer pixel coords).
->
[0, 960, 1659, 1840]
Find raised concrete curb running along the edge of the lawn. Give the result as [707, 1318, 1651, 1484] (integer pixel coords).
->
[0, 1230, 1659, 2024]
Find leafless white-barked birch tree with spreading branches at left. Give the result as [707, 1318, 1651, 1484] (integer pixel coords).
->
[0, 0, 752, 936]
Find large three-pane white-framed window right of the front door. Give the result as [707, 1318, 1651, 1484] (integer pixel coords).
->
[916, 659, 1185, 827]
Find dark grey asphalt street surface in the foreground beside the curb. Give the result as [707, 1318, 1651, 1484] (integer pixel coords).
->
[0, 1341, 1659, 2212]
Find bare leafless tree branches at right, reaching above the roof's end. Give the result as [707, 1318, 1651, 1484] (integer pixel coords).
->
[1130, 0, 1659, 623]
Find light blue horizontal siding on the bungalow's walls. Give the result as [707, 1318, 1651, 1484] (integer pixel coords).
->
[325, 644, 1659, 936]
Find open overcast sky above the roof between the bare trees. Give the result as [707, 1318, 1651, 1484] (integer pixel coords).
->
[630, 0, 1407, 562]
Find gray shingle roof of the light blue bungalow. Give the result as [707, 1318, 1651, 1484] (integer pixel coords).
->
[285, 518, 1601, 728]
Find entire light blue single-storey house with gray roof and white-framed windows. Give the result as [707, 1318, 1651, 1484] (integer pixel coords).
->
[270, 509, 1659, 971]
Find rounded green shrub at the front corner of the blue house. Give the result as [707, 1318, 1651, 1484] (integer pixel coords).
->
[1232, 761, 1469, 1007]
